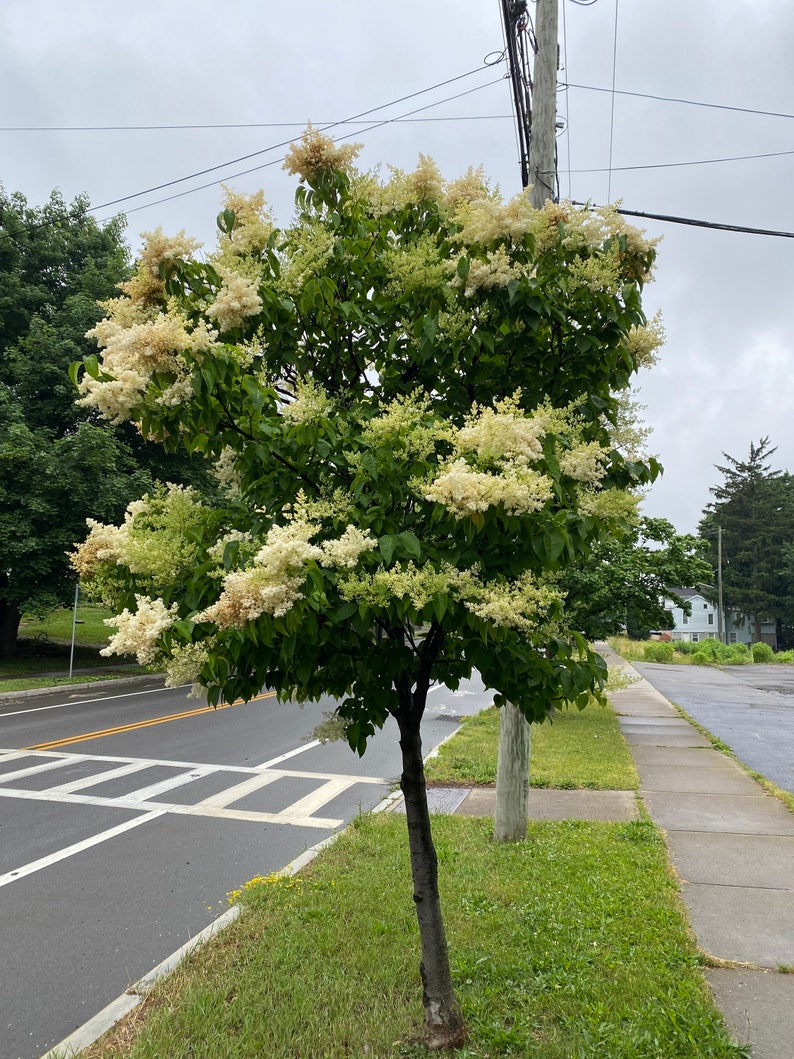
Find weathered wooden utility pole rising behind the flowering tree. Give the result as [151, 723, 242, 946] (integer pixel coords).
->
[493, 0, 558, 842]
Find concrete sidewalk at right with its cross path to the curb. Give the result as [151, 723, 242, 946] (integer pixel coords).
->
[419, 645, 794, 1059]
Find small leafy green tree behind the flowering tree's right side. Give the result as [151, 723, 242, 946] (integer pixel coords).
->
[561, 518, 714, 640]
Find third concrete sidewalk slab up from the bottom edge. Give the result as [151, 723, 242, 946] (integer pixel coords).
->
[667, 831, 794, 889]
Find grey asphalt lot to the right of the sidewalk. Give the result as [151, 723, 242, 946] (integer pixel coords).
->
[632, 662, 794, 793]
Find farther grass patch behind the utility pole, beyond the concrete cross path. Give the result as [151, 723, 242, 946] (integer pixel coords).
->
[426, 702, 639, 790]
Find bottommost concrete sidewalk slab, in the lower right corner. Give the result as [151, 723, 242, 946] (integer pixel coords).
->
[706, 967, 794, 1059]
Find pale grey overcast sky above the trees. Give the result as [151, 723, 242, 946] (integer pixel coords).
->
[0, 0, 794, 533]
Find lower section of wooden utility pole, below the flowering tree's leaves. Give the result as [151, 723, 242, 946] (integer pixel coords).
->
[493, 702, 530, 842]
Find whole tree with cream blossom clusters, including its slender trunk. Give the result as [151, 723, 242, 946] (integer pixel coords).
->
[73, 129, 657, 1046]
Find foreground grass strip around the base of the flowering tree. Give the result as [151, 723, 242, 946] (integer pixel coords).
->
[86, 813, 748, 1059]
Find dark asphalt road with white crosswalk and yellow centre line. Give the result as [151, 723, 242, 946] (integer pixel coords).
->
[0, 684, 490, 1059]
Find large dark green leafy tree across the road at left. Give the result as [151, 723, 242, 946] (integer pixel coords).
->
[0, 189, 211, 659]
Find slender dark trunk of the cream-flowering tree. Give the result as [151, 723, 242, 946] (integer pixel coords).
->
[398, 693, 466, 1048]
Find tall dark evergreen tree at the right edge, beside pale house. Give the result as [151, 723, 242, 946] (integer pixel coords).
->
[700, 437, 794, 641]
